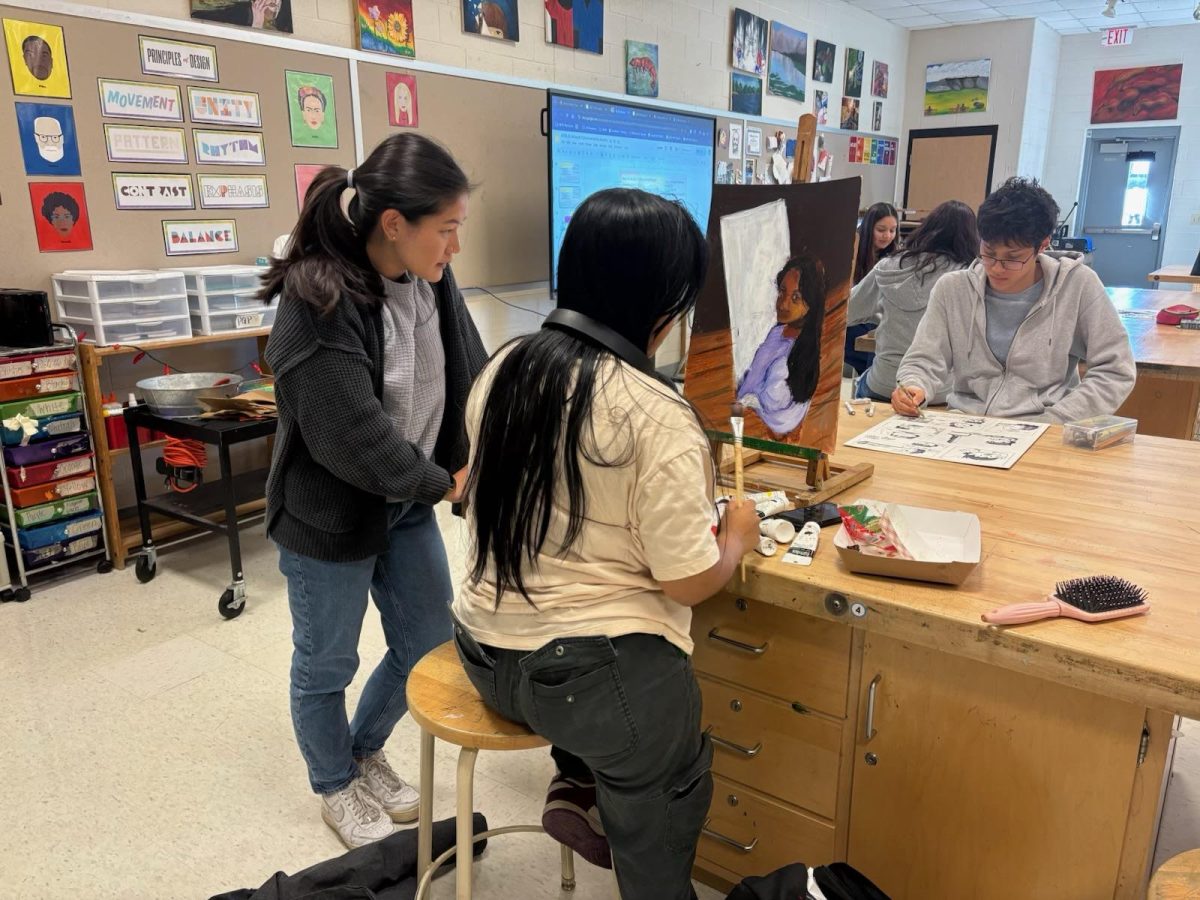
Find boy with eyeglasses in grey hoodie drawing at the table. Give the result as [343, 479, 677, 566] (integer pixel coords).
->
[892, 178, 1136, 422]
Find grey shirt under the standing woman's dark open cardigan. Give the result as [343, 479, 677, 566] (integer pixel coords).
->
[382, 275, 446, 475]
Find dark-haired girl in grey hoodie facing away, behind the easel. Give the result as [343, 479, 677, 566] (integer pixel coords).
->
[846, 200, 979, 402]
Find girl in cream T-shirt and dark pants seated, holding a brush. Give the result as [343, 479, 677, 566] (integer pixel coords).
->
[454, 188, 758, 900]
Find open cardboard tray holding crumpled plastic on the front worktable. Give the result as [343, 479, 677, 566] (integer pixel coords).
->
[833, 500, 982, 584]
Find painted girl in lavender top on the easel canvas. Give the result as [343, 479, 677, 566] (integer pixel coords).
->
[738, 253, 827, 437]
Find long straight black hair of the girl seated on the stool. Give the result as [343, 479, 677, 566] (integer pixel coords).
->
[467, 188, 708, 605]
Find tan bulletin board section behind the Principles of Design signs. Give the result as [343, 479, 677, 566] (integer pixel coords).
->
[0, 6, 355, 296]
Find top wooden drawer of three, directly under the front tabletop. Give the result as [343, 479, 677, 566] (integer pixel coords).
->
[691, 593, 851, 718]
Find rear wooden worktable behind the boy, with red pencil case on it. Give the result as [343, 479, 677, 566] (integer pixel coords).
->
[854, 289, 1200, 440]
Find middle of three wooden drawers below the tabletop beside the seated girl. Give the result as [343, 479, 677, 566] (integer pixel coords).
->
[700, 676, 844, 818]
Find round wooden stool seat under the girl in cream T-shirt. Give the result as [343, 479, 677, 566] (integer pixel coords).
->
[408, 641, 548, 750]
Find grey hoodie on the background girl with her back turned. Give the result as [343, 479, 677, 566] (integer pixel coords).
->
[846, 253, 962, 397]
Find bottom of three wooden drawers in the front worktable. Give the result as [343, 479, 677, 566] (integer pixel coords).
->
[696, 775, 834, 877]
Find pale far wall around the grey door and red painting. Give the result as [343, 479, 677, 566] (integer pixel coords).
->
[1045, 27, 1200, 278]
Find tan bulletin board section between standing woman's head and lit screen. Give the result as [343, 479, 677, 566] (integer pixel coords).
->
[359, 62, 550, 287]
